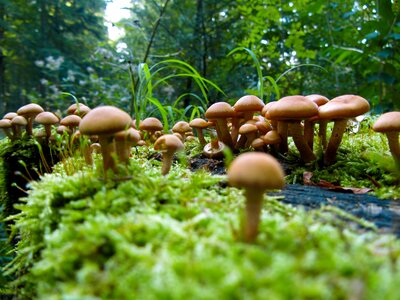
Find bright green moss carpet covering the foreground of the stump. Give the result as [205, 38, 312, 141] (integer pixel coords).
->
[3, 154, 400, 299]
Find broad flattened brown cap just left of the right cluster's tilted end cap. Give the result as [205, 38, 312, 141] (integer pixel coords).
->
[266, 95, 318, 120]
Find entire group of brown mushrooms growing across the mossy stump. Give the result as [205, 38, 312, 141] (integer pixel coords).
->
[0, 94, 400, 242]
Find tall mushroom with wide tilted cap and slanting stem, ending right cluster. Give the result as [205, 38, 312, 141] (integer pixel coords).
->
[318, 95, 370, 165]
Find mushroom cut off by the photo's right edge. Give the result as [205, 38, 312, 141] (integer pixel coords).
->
[372, 111, 400, 167]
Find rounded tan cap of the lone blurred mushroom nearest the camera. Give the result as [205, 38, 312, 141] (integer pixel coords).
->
[227, 152, 285, 190]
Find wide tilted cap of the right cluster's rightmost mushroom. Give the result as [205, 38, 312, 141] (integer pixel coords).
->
[319, 95, 370, 119]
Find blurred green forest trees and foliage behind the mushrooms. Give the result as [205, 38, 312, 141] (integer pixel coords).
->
[0, 0, 400, 121]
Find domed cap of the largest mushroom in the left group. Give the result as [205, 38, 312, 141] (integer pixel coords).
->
[79, 105, 132, 136]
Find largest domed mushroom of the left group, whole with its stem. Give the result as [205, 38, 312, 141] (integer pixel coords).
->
[79, 106, 132, 177]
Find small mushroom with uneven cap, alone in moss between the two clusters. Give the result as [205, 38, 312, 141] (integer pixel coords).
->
[154, 134, 184, 176]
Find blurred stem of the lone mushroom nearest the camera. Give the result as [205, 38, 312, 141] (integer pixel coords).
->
[242, 188, 264, 243]
